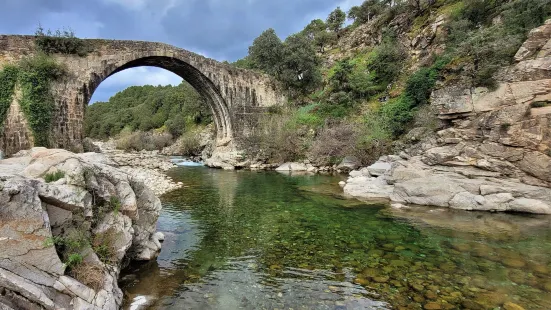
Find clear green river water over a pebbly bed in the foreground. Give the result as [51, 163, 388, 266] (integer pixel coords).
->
[120, 168, 551, 309]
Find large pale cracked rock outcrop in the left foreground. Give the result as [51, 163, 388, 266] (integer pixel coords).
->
[0, 148, 162, 309]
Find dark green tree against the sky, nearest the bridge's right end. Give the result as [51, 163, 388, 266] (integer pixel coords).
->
[249, 28, 283, 77]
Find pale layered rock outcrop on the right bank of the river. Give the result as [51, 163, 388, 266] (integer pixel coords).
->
[344, 20, 551, 214]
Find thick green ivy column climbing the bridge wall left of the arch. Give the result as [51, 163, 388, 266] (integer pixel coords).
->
[18, 53, 65, 147]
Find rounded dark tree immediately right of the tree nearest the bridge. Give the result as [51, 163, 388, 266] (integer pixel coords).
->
[280, 34, 321, 93]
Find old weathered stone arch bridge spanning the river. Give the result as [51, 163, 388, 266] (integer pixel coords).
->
[0, 35, 286, 162]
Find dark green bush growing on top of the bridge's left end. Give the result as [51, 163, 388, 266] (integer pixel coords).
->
[35, 26, 91, 57]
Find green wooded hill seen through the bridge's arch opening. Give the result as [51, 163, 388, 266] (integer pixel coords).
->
[84, 82, 212, 139]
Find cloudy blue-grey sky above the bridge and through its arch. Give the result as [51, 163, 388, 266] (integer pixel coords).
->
[0, 0, 363, 103]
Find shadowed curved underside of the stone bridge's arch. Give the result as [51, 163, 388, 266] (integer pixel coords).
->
[90, 56, 233, 144]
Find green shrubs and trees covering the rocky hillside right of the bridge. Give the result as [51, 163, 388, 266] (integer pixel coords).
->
[234, 0, 551, 165]
